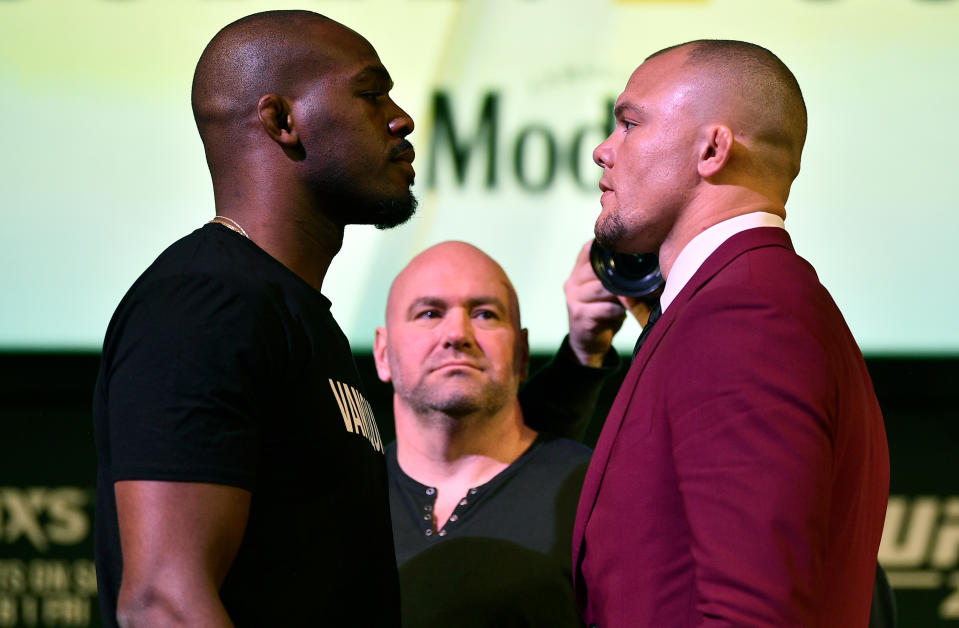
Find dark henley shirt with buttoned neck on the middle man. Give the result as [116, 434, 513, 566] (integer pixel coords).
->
[386, 434, 590, 628]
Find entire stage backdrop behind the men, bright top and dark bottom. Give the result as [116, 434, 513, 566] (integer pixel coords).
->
[0, 0, 959, 628]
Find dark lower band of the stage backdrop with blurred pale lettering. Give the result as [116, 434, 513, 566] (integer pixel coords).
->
[0, 353, 959, 628]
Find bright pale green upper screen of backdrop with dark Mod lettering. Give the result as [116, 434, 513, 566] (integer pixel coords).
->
[0, 0, 959, 354]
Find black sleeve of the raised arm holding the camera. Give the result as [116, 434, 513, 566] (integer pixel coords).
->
[519, 336, 620, 441]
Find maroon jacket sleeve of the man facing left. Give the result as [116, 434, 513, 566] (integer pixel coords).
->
[671, 294, 835, 626]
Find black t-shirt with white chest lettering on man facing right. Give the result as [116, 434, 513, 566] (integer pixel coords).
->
[94, 224, 399, 627]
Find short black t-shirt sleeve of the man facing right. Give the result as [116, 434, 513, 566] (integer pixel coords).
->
[105, 276, 279, 490]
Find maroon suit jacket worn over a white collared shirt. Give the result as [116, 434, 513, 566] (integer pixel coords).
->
[573, 227, 889, 628]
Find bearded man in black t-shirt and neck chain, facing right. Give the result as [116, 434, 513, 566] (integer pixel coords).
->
[94, 11, 415, 627]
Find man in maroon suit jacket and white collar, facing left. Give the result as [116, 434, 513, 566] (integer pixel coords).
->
[573, 41, 889, 628]
